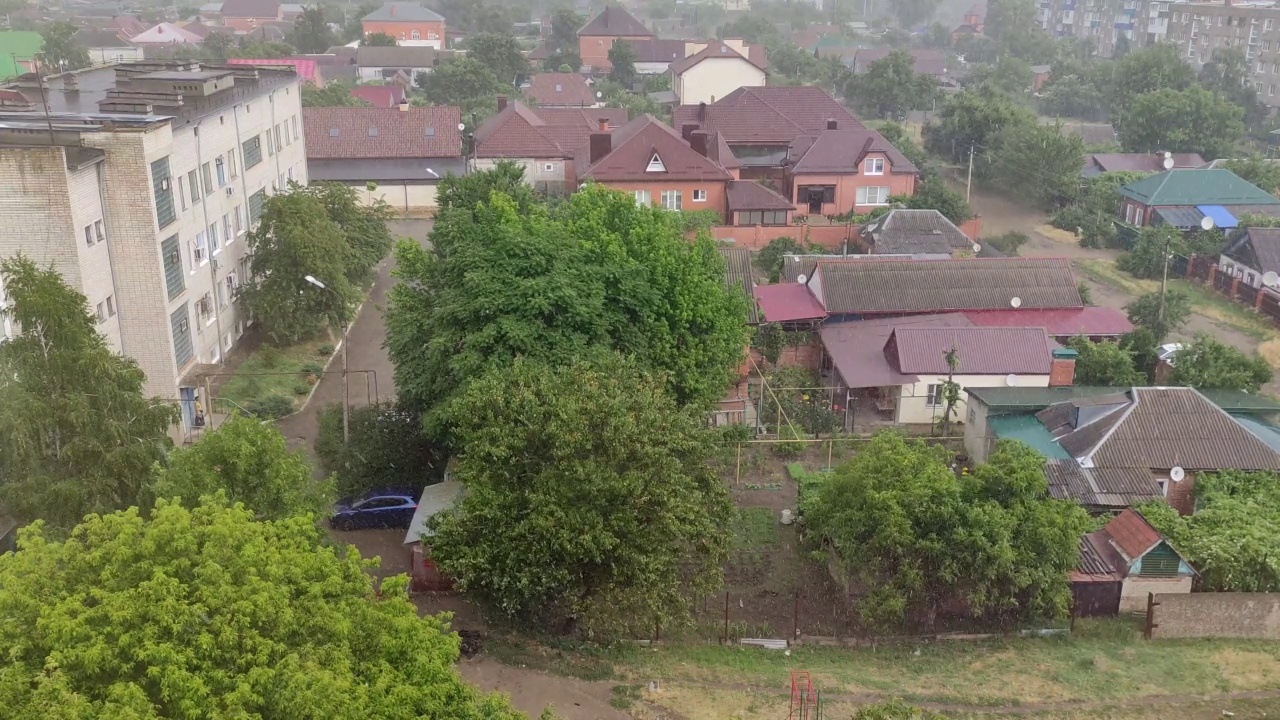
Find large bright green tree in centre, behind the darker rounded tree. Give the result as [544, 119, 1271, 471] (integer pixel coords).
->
[387, 170, 748, 420]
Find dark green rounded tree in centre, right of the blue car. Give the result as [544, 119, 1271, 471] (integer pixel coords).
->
[431, 351, 731, 635]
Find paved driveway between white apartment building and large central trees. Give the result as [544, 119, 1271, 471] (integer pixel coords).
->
[279, 219, 433, 452]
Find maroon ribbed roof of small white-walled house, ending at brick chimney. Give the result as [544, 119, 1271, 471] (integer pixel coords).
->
[884, 322, 1056, 375]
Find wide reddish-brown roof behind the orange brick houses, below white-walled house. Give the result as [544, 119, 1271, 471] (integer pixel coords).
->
[672, 86, 863, 145]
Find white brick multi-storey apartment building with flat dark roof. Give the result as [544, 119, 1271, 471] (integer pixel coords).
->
[0, 63, 307, 425]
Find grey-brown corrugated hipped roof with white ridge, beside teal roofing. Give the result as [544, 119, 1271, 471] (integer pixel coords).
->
[1059, 387, 1280, 471]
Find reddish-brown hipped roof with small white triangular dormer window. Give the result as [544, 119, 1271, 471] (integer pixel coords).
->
[582, 114, 732, 182]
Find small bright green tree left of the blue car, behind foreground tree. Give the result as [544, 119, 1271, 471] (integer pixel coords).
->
[152, 415, 333, 520]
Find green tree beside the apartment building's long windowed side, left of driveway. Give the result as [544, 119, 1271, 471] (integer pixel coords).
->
[239, 192, 358, 345]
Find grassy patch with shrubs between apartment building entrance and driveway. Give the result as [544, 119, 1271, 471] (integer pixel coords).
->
[218, 338, 334, 418]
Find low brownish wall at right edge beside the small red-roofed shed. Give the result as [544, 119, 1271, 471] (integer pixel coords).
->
[1151, 592, 1280, 639]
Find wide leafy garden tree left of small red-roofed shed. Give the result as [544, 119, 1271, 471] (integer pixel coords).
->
[803, 432, 1089, 628]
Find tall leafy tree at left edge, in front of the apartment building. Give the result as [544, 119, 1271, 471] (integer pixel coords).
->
[0, 256, 178, 528]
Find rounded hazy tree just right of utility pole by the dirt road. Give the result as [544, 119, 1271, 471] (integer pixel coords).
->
[988, 123, 1084, 208]
